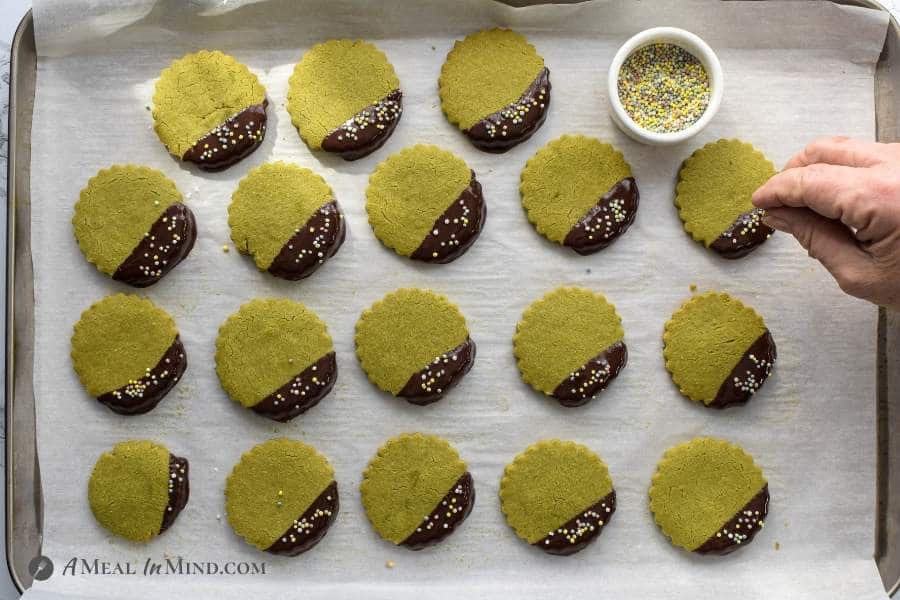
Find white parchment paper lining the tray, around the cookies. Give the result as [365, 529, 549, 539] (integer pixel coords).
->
[29, 0, 886, 598]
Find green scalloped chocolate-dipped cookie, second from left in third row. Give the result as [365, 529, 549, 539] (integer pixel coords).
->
[216, 298, 337, 423]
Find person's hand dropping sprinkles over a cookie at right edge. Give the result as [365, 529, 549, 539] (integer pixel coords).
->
[753, 137, 900, 309]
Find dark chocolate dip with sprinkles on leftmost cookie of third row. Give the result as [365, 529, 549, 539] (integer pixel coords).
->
[97, 335, 187, 415]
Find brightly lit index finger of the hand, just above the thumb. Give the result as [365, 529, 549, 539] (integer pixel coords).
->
[752, 164, 870, 229]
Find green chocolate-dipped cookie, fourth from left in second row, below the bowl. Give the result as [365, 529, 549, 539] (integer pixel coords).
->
[519, 135, 640, 255]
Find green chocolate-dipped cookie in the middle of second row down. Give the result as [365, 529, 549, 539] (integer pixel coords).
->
[366, 144, 487, 263]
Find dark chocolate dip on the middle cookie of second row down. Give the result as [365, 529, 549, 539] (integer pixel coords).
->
[410, 171, 487, 264]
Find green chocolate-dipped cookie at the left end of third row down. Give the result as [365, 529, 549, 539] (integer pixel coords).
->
[72, 294, 187, 415]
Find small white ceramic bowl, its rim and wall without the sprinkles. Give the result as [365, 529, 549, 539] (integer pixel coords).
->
[607, 27, 725, 146]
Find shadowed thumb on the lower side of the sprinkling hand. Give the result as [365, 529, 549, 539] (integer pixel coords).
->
[763, 207, 873, 296]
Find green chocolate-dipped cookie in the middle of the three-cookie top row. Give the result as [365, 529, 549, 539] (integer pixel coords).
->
[287, 40, 403, 160]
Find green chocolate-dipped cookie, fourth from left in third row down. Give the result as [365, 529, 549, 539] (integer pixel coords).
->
[513, 287, 628, 406]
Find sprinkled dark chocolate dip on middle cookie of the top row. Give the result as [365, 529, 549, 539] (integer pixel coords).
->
[322, 90, 403, 160]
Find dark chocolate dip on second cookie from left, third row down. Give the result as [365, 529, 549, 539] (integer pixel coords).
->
[251, 352, 337, 423]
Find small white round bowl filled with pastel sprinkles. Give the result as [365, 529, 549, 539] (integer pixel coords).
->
[608, 27, 724, 145]
